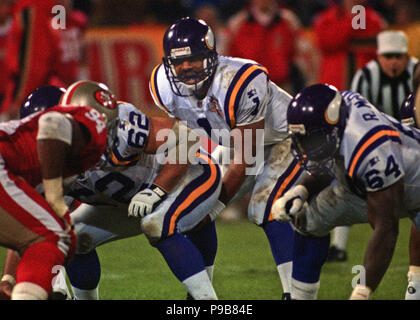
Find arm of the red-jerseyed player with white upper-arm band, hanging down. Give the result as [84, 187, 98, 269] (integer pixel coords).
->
[37, 112, 89, 217]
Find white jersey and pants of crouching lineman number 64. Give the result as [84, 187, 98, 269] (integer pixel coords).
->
[304, 91, 420, 236]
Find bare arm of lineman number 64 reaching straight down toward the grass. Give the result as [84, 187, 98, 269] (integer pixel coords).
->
[350, 179, 404, 299]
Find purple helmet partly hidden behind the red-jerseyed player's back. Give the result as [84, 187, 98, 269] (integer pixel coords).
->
[19, 86, 66, 119]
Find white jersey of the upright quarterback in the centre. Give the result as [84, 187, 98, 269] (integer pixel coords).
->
[149, 56, 292, 145]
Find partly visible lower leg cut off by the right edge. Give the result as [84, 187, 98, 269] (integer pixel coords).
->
[405, 223, 420, 300]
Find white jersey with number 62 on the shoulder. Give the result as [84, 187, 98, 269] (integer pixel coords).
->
[68, 102, 162, 205]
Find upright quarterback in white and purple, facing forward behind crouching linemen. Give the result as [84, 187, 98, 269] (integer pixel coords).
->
[149, 18, 316, 298]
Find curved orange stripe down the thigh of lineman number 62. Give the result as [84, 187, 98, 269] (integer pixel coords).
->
[168, 152, 217, 235]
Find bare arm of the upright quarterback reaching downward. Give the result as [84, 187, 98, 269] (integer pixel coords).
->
[219, 120, 264, 205]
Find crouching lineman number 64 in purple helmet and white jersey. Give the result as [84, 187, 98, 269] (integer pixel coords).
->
[273, 84, 420, 299]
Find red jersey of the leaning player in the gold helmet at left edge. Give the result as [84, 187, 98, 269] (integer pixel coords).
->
[0, 106, 107, 187]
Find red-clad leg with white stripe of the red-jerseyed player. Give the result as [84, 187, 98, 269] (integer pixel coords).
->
[0, 168, 75, 300]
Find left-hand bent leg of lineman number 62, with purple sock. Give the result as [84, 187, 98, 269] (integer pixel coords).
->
[66, 204, 141, 300]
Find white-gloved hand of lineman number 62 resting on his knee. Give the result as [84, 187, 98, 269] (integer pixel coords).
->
[128, 185, 167, 218]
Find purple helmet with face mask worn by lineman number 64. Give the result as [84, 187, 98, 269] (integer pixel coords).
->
[287, 84, 347, 173]
